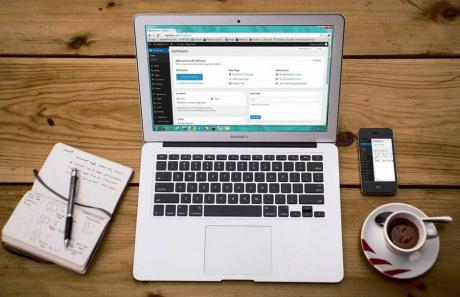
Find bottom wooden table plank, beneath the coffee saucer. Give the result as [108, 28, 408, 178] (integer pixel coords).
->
[0, 186, 460, 297]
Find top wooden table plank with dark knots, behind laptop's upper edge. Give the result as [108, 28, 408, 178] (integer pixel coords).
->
[0, 0, 460, 56]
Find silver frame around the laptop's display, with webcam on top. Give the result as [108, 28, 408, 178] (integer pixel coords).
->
[134, 14, 345, 142]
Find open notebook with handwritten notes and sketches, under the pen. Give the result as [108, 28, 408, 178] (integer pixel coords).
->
[2, 143, 133, 273]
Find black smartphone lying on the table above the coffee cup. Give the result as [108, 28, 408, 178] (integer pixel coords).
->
[358, 128, 398, 195]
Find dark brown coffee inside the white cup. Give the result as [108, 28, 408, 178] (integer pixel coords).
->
[388, 218, 420, 249]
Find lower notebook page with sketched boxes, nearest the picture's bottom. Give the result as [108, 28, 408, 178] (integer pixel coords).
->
[3, 191, 110, 267]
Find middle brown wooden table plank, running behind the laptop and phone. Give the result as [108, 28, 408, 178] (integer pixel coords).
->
[0, 58, 460, 185]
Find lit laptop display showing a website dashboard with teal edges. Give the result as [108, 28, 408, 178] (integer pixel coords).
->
[145, 25, 333, 132]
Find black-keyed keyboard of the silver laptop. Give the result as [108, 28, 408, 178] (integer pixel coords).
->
[153, 154, 325, 218]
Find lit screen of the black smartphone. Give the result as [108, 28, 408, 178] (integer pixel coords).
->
[360, 138, 396, 182]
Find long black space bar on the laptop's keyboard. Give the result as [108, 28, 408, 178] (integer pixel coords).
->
[204, 205, 262, 217]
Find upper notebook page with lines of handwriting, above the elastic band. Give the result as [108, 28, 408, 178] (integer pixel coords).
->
[32, 143, 132, 213]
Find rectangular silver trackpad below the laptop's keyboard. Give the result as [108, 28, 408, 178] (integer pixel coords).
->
[204, 226, 272, 275]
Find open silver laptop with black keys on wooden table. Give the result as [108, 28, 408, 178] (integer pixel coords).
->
[133, 14, 344, 283]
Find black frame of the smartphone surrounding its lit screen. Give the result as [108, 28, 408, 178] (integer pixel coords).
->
[358, 128, 398, 195]
